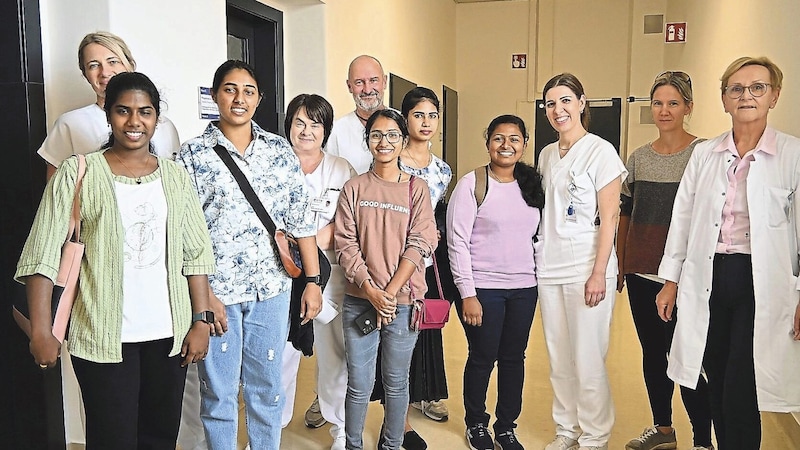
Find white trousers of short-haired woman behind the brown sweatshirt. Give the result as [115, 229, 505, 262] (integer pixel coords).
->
[281, 264, 347, 438]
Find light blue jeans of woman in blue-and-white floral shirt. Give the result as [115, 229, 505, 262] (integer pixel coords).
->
[198, 291, 289, 450]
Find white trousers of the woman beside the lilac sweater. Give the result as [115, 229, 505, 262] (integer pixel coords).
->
[539, 278, 616, 447]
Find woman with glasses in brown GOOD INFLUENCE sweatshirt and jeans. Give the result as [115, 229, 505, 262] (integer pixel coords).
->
[334, 109, 437, 450]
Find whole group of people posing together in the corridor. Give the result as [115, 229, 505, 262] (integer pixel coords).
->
[15, 27, 800, 450]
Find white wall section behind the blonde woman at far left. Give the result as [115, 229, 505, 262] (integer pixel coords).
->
[40, 0, 226, 144]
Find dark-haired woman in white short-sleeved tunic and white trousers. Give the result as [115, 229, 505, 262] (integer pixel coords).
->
[536, 73, 628, 450]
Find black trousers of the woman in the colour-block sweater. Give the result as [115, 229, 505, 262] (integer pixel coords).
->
[625, 274, 711, 447]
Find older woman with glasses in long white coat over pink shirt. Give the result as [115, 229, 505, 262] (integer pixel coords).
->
[656, 57, 800, 450]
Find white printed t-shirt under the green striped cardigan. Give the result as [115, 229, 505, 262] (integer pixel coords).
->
[114, 169, 173, 342]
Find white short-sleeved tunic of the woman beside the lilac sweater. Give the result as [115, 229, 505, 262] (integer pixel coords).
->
[536, 133, 628, 284]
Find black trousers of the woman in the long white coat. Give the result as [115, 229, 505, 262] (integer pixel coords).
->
[703, 254, 761, 450]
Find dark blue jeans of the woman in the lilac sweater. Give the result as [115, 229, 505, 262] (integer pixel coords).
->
[456, 287, 538, 433]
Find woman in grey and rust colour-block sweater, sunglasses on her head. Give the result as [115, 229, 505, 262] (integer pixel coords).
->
[617, 72, 713, 450]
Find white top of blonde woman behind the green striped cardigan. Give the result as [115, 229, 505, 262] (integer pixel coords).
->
[37, 103, 181, 167]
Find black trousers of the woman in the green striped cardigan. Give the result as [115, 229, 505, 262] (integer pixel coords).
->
[72, 338, 186, 450]
